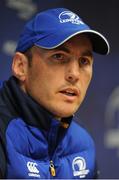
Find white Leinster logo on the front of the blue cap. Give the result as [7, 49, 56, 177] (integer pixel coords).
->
[59, 11, 84, 25]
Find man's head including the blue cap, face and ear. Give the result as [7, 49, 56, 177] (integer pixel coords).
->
[12, 8, 109, 118]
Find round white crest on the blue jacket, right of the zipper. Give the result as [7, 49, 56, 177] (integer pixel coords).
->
[72, 157, 89, 178]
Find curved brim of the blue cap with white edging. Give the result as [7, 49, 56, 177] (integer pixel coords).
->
[34, 29, 110, 55]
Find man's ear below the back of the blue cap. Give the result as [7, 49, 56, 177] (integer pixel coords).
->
[12, 52, 28, 82]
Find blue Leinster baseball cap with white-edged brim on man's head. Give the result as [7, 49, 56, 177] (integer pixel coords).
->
[16, 8, 110, 54]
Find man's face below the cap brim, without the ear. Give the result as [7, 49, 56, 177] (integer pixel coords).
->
[23, 35, 93, 118]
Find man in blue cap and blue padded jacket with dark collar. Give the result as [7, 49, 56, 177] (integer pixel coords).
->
[0, 8, 109, 179]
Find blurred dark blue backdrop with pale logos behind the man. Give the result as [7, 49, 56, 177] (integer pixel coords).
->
[0, 0, 119, 178]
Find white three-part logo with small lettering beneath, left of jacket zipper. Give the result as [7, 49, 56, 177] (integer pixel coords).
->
[27, 161, 40, 177]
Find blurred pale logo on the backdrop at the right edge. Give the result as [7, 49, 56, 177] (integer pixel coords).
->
[104, 86, 119, 156]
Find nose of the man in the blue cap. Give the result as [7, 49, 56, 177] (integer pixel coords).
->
[66, 60, 80, 84]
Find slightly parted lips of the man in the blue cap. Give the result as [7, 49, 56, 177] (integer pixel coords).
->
[60, 88, 80, 96]
